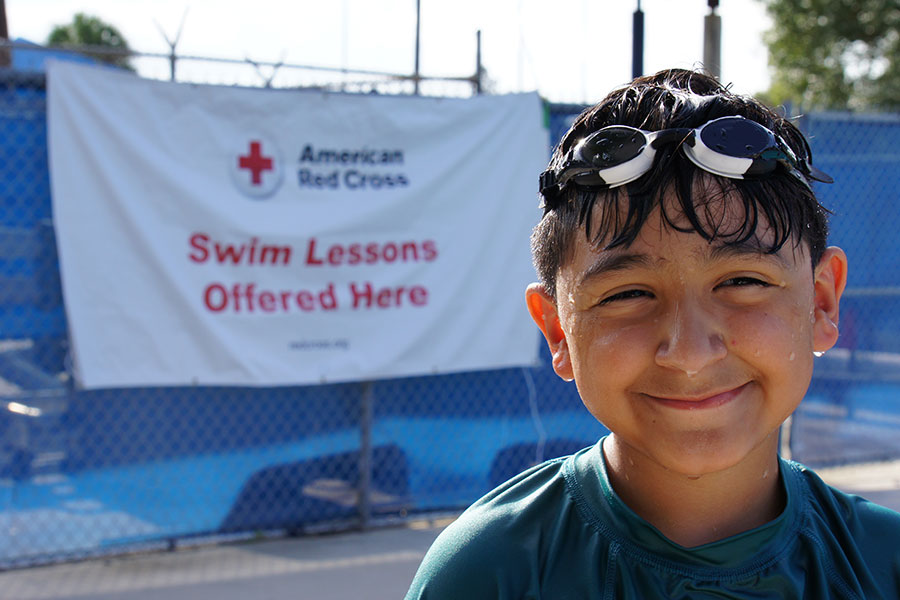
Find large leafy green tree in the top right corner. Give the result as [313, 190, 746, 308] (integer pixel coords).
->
[762, 0, 900, 110]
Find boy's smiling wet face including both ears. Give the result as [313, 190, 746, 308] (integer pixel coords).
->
[528, 192, 846, 476]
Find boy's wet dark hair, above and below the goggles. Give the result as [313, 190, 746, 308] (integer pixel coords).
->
[531, 69, 828, 296]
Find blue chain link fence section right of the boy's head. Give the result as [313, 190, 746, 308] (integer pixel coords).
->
[791, 113, 900, 466]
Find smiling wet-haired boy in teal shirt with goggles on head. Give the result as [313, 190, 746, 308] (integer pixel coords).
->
[407, 70, 900, 600]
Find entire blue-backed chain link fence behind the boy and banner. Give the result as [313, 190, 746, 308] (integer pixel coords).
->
[0, 54, 900, 568]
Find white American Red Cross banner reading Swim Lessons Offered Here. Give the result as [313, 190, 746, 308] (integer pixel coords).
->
[48, 63, 547, 388]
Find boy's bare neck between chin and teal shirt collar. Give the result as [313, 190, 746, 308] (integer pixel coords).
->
[603, 434, 786, 548]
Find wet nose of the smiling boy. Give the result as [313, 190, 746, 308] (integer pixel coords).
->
[656, 302, 728, 375]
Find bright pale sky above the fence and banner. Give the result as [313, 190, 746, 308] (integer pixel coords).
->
[6, 0, 771, 103]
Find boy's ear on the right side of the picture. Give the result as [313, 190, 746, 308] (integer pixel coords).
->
[813, 246, 847, 352]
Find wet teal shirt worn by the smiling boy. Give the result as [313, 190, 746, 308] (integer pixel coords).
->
[406, 440, 900, 600]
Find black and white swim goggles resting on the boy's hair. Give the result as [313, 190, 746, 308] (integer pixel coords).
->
[540, 116, 834, 204]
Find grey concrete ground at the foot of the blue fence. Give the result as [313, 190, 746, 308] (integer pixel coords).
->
[0, 461, 900, 600]
